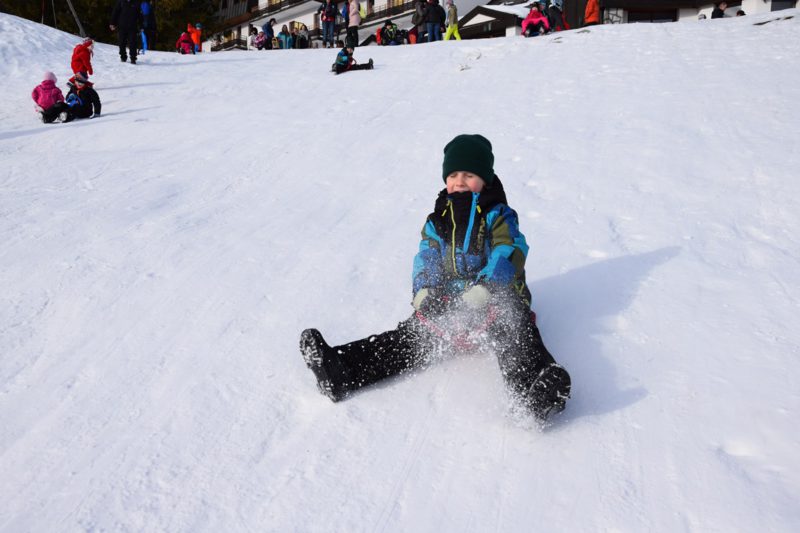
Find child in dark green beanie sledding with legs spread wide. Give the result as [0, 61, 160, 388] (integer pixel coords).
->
[300, 135, 570, 420]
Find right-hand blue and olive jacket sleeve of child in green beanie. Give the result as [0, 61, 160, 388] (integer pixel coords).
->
[477, 206, 528, 286]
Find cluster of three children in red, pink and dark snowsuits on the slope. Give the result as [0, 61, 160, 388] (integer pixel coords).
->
[31, 38, 102, 124]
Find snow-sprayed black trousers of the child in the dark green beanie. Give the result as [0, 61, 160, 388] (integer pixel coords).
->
[333, 302, 555, 397]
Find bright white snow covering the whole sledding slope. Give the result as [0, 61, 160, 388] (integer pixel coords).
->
[0, 10, 800, 532]
